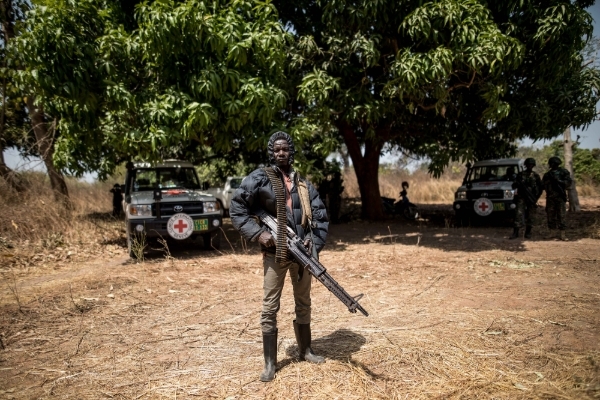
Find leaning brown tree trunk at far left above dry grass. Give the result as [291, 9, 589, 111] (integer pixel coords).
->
[27, 96, 72, 209]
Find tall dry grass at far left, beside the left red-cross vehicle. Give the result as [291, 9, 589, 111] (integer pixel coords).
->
[0, 172, 116, 246]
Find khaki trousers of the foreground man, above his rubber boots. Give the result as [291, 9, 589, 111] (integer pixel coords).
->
[260, 253, 311, 333]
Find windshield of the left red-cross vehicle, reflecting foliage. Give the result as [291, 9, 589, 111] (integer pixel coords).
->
[133, 168, 200, 192]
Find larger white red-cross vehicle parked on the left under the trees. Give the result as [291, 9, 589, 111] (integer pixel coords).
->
[123, 160, 223, 257]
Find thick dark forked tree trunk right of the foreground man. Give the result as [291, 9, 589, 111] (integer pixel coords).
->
[338, 122, 384, 220]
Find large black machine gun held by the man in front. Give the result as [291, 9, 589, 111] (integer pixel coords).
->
[256, 210, 369, 317]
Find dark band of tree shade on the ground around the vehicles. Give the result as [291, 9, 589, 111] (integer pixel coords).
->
[114, 204, 600, 261]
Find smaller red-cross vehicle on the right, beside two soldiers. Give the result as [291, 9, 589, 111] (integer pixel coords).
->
[453, 158, 525, 226]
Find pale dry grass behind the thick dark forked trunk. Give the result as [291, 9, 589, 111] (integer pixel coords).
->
[343, 168, 462, 204]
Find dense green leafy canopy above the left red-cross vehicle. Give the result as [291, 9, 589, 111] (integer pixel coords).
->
[15, 0, 289, 177]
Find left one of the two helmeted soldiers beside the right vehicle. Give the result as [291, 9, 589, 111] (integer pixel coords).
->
[510, 158, 544, 239]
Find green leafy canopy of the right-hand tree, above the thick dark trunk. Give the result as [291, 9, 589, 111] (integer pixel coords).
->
[276, 0, 600, 174]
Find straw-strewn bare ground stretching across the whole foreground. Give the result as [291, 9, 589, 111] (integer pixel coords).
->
[0, 201, 600, 399]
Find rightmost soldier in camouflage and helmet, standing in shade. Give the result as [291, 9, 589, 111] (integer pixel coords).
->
[542, 157, 573, 240]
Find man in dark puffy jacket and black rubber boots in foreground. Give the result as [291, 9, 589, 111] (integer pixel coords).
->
[229, 132, 329, 382]
